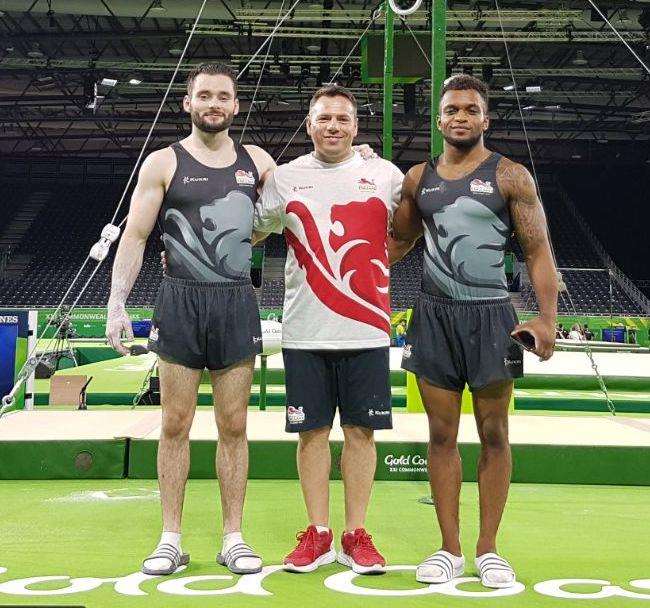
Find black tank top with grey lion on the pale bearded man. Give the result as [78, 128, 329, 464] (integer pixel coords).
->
[160, 143, 259, 282]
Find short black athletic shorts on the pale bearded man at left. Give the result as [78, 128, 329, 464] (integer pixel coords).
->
[149, 276, 262, 369]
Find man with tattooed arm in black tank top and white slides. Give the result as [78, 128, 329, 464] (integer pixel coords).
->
[393, 75, 558, 588]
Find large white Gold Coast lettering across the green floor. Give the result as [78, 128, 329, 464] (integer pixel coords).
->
[0, 565, 650, 607]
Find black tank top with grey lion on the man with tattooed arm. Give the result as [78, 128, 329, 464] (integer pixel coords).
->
[416, 152, 511, 300]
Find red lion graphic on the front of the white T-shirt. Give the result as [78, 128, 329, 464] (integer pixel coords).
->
[285, 197, 390, 333]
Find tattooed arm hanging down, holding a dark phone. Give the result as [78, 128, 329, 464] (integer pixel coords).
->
[497, 159, 558, 360]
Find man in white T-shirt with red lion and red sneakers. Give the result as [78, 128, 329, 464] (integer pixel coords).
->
[255, 86, 403, 574]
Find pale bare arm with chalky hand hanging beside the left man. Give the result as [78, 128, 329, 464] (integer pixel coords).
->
[106, 150, 169, 355]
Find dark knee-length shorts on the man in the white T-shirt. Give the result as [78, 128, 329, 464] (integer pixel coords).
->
[282, 347, 393, 433]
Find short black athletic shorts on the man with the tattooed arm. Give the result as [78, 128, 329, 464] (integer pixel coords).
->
[402, 293, 524, 392]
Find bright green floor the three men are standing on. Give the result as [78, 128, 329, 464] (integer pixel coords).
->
[0, 480, 650, 608]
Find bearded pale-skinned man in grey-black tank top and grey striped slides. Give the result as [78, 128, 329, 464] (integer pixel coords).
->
[106, 64, 275, 575]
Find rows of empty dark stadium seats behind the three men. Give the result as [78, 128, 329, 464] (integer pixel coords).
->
[0, 178, 642, 315]
